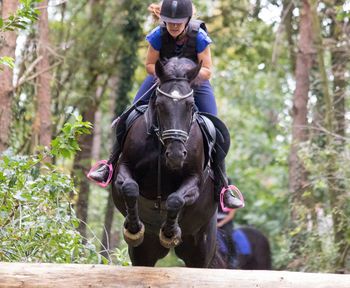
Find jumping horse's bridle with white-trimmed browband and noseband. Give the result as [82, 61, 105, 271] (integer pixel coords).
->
[156, 78, 193, 145]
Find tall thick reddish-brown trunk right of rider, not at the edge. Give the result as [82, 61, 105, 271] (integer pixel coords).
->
[289, 0, 312, 254]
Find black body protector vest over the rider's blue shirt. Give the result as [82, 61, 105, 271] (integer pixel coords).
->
[159, 19, 207, 63]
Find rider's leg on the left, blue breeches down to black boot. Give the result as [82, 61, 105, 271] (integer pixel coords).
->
[90, 75, 156, 182]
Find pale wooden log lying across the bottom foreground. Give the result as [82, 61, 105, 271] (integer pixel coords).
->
[0, 262, 350, 288]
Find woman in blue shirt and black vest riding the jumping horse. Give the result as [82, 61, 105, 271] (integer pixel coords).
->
[90, 0, 242, 208]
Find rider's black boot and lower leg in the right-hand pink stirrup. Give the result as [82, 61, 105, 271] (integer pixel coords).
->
[212, 159, 243, 209]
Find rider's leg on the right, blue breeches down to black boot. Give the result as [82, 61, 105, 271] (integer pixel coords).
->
[194, 80, 243, 208]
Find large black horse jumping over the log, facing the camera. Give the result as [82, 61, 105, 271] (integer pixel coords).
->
[112, 58, 217, 267]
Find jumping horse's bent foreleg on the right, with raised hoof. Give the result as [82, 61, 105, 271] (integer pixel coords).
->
[159, 177, 199, 248]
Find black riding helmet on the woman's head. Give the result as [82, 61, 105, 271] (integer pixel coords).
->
[160, 0, 193, 24]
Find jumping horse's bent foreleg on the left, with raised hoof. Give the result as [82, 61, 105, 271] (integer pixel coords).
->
[117, 164, 145, 247]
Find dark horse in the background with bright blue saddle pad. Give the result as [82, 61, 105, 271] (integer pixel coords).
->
[211, 226, 271, 270]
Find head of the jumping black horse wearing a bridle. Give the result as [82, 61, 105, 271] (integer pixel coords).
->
[153, 57, 201, 170]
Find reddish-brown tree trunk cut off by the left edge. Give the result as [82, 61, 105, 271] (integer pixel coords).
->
[0, 0, 18, 159]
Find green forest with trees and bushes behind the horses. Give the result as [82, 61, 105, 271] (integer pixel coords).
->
[0, 0, 350, 273]
